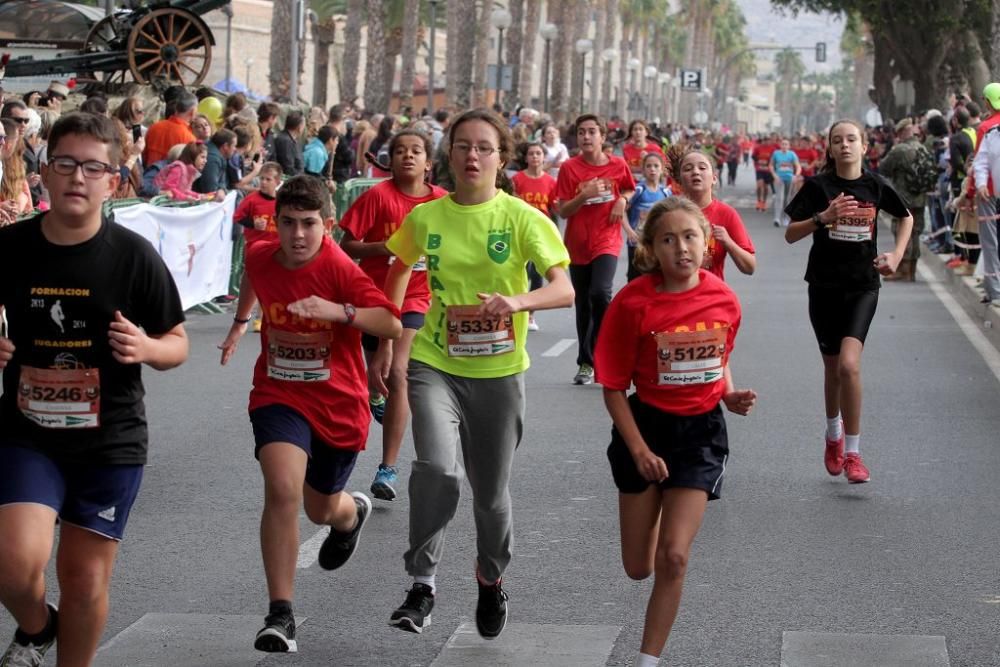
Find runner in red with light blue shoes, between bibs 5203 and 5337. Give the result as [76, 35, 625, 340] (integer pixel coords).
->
[340, 130, 448, 500]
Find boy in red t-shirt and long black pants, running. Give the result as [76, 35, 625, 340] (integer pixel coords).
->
[556, 114, 635, 384]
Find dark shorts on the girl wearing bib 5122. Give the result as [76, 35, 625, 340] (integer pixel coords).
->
[608, 394, 729, 500]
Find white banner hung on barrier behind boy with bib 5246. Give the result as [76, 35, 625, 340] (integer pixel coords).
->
[114, 192, 236, 310]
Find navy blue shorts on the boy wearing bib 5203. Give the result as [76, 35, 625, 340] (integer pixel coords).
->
[250, 403, 358, 496]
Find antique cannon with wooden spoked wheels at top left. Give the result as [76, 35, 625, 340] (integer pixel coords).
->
[0, 0, 230, 86]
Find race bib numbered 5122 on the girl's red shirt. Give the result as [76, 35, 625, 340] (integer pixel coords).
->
[654, 325, 729, 386]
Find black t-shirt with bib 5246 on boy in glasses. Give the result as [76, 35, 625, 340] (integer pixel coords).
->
[0, 214, 184, 464]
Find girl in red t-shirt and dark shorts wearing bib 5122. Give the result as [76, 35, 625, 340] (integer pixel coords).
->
[594, 197, 757, 667]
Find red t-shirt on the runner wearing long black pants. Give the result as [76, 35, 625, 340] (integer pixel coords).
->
[556, 155, 635, 264]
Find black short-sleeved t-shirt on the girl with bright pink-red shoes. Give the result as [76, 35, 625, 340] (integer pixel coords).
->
[785, 170, 909, 290]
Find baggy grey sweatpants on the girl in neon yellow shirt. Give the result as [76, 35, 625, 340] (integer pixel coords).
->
[403, 361, 524, 581]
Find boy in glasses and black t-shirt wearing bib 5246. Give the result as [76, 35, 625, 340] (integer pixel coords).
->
[0, 113, 188, 666]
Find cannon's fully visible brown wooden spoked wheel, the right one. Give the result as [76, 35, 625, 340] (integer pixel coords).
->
[128, 8, 212, 86]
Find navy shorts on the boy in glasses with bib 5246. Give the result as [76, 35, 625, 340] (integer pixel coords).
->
[0, 443, 142, 541]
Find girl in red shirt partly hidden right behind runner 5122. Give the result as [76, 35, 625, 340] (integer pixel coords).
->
[677, 150, 757, 279]
